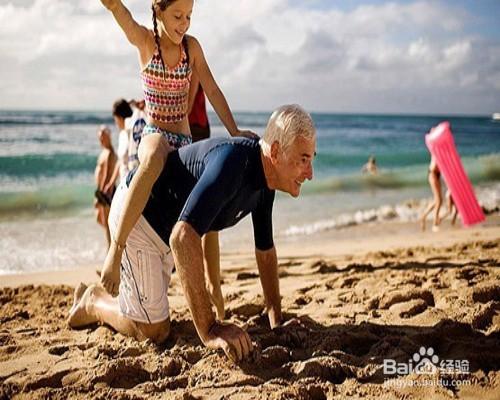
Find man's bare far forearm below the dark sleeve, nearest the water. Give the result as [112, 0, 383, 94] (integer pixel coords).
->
[255, 246, 281, 329]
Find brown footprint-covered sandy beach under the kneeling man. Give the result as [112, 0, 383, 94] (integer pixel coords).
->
[0, 216, 500, 400]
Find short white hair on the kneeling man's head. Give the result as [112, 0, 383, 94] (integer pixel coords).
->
[261, 104, 316, 153]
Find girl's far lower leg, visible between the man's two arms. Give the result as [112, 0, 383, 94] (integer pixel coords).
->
[202, 232, 225, 321]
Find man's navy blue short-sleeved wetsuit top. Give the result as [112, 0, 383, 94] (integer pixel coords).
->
[137, 138, 275, 250]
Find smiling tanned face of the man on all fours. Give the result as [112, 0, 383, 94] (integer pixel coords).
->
[273, 136, 316, 197]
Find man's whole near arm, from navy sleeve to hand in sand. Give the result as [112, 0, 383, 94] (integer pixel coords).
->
[170, 146, 252, 361]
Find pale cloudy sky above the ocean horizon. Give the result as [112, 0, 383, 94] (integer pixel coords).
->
[0, 0, 500, 115]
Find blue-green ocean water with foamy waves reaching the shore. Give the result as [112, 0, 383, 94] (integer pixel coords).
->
[0, 111, 500, 274]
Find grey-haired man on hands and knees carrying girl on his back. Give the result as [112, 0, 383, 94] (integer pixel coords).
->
[68, 105, 316, 360]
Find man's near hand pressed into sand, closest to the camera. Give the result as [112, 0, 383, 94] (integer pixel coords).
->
[204, 322, 253, 362]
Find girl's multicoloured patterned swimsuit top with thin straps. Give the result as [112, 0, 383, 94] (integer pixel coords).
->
[141, 41, 192, 124]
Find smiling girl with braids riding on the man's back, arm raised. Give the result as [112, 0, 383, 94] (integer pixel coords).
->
[101, 0, 256, 314]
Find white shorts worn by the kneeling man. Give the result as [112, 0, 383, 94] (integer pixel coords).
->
[108, 182, 174, 324]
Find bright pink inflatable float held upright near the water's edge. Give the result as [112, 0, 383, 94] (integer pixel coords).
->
[425, 122, 484, 226]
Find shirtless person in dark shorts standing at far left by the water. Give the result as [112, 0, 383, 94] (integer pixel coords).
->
[94, 125, 117, 248]
